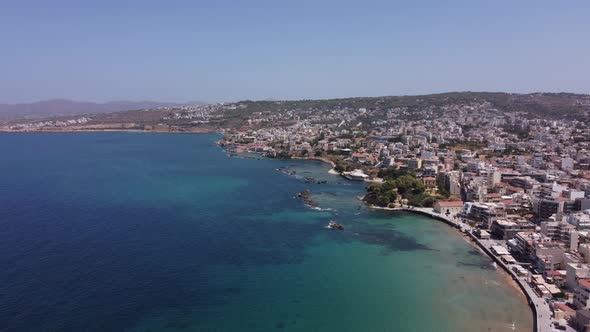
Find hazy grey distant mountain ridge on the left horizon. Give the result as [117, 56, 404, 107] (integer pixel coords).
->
[0, 99, 195, 120]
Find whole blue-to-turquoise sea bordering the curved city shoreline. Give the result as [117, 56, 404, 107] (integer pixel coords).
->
[0, 133, 532, 331]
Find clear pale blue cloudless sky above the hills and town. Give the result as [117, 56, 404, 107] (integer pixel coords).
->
[0, 0, 590, 103]
